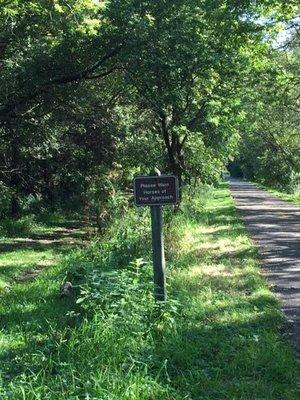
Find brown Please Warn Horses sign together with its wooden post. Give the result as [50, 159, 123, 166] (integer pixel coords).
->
[134, 170, 179, 301]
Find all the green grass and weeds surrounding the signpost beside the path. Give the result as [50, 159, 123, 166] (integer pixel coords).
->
[0, 186, 299, 400]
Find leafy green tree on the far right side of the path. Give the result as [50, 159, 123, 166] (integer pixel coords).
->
[237, 25, 300, 189]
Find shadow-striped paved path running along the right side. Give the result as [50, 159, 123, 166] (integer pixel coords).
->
[230, 179, 300, 354]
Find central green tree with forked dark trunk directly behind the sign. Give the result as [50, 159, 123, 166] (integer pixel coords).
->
[102, 0, 296, 185]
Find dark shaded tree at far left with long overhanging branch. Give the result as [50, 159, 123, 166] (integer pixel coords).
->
[0, 0, 127, 216]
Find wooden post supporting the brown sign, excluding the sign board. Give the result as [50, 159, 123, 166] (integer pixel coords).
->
[151, 170, 167, 301]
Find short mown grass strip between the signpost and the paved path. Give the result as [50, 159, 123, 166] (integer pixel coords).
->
[166, 184, 297, 399]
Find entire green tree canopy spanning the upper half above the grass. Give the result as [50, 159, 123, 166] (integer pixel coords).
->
[0, 0, 299, 215]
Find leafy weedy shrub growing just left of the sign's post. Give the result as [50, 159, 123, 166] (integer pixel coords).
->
[66, 198, 180, 329]
